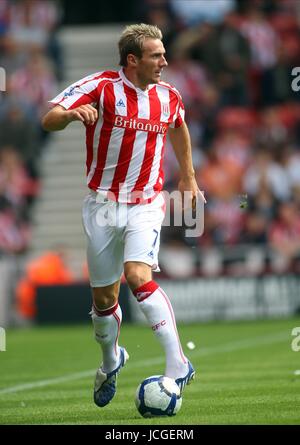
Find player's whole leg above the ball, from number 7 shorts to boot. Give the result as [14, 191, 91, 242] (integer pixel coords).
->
[124, 193, 195, 388]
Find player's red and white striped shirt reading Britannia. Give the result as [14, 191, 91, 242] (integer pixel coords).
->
[50, 69, 184, 203]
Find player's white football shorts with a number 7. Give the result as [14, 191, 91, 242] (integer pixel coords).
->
[82, 191, 165, 287]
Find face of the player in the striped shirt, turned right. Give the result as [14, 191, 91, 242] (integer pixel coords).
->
[136, 39, 168, 86]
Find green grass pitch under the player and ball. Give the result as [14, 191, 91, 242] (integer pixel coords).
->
[0, 318, 300, 425]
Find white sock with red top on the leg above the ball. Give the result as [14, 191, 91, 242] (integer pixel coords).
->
[133, 281, 188, 379]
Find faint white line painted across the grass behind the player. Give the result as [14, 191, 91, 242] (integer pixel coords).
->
[0, 331, 289, 396]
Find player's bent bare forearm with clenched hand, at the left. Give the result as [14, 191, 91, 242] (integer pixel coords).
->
[42, 104, 98, 131]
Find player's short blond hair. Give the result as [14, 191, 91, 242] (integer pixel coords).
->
[119, 23, 162, 66]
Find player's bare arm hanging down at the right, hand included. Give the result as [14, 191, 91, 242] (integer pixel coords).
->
[169, 121, 206, 202]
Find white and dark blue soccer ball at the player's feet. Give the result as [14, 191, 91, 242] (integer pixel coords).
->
[135, 375, 182, 417]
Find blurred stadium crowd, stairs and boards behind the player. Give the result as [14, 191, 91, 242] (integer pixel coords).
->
[0, 0, 300, 327]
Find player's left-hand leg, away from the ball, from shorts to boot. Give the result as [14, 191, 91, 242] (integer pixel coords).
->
[83, 195, 128, 406]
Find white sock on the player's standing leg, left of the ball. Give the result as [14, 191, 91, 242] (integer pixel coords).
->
[91, 303, 122, 373]
